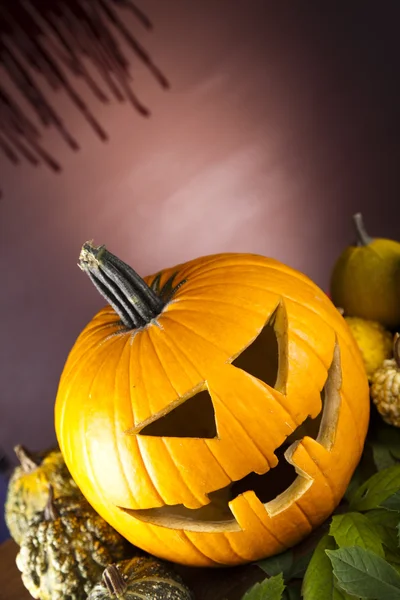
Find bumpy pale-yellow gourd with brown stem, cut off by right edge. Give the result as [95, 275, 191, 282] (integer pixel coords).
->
[371, 333, 400, 427]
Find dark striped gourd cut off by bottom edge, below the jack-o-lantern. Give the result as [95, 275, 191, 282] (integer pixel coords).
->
[88, 556, 193, 600]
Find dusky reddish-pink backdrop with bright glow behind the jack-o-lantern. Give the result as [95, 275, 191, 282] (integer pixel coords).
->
[0, 0, 400, 478]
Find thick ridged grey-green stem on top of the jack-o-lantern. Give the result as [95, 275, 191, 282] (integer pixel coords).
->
[78, 242, 166, 329]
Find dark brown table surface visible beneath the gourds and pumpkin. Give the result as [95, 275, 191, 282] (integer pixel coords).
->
[0, 540, 265, 600]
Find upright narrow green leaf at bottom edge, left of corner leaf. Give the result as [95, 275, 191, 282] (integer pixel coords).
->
[301, 535, 354, 600]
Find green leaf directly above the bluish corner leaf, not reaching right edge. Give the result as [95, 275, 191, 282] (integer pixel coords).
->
[329, 512, 385, 558]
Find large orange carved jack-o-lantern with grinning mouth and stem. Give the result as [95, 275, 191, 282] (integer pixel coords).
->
[56, 243, 369, 566]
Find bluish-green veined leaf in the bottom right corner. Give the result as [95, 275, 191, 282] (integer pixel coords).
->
[326, 547, 400, 600]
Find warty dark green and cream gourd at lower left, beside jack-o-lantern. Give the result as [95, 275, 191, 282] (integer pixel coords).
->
[16, 488, 132, 600]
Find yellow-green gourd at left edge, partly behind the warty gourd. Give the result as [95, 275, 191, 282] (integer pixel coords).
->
[5, 445, 82, 545]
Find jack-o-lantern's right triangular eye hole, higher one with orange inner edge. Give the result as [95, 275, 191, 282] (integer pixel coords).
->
[232, 305, 286, 391]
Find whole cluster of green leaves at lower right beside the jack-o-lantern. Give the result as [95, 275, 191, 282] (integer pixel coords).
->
[242, 418, 400, 600]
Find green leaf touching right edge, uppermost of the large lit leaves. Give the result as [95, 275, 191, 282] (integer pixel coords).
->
[350, 465, 400, 511]
